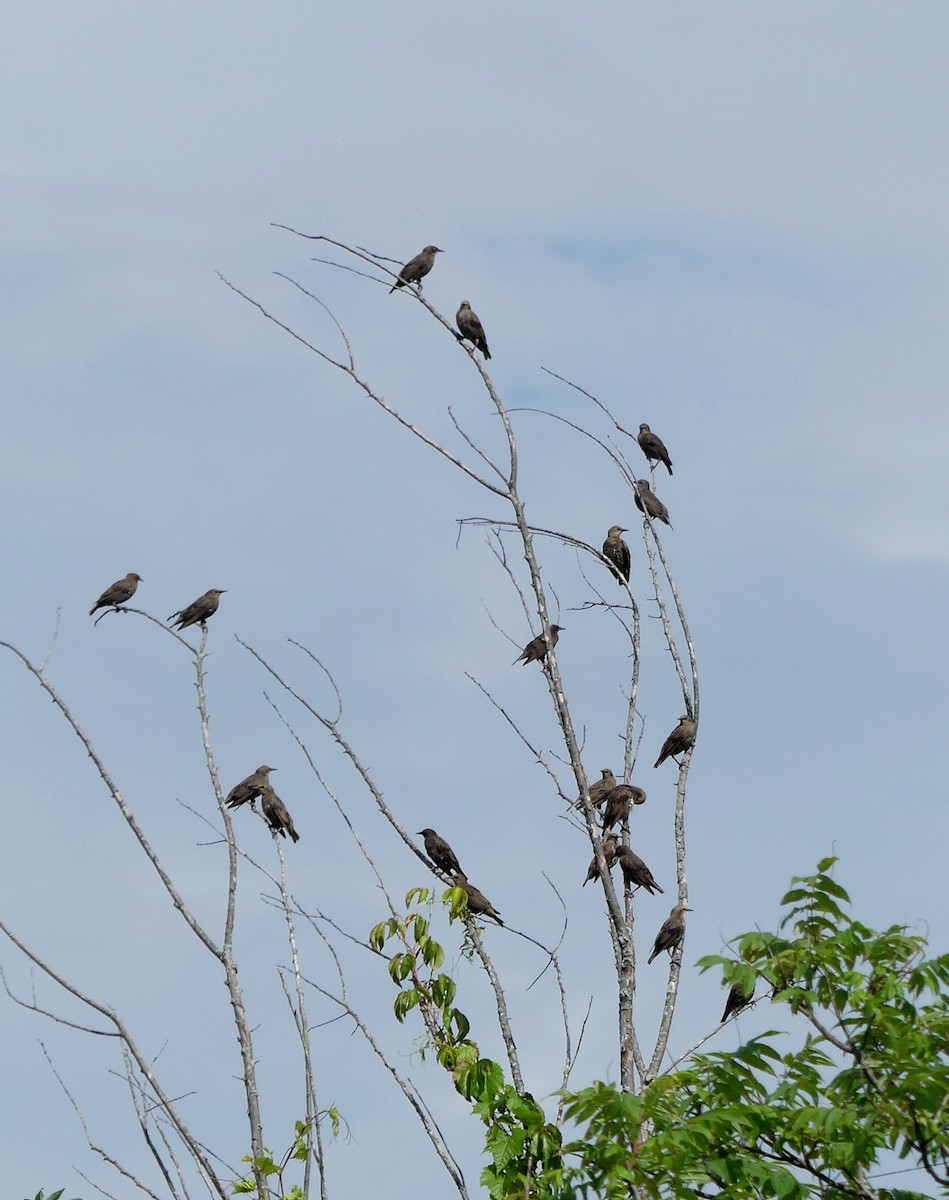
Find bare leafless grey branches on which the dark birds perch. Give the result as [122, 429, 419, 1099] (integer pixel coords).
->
[0, 230, 698, 1200]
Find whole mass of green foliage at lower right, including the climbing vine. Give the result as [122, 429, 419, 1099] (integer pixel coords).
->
[373, 858, 949, 1200]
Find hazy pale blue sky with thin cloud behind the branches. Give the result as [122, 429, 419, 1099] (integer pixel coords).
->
[0, 0, 949, 1200]
